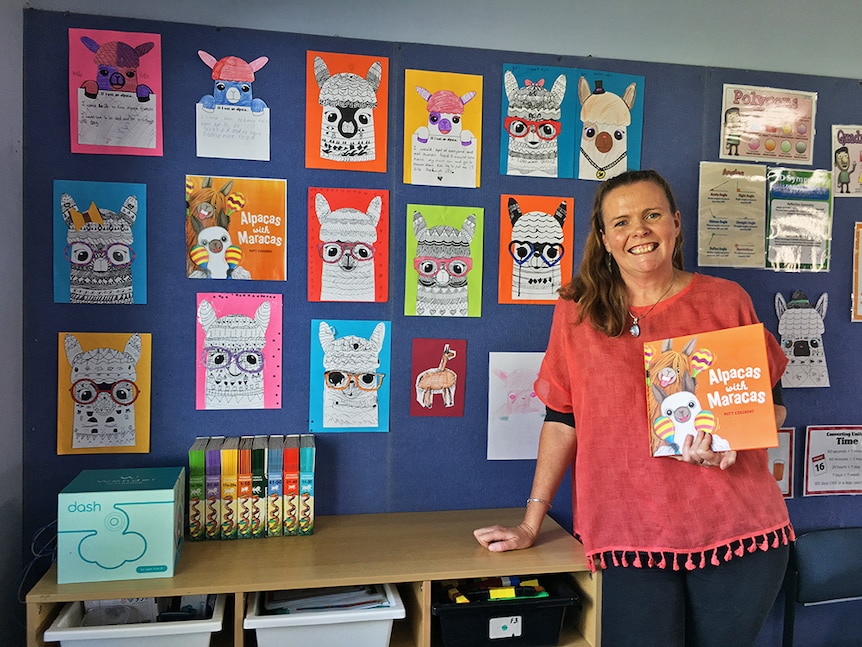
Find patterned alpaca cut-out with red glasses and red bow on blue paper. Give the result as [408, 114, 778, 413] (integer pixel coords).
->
[503, 70, 566, 177]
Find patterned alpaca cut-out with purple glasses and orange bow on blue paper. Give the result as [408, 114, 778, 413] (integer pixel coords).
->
[60, 193, 138, 304]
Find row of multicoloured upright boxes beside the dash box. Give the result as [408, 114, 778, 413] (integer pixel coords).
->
[188, 434, 316, 541]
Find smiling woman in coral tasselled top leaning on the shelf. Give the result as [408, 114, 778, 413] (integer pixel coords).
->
[474, 171, 793, 647]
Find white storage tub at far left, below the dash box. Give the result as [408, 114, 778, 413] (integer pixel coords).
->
[45, 595, 226, 647]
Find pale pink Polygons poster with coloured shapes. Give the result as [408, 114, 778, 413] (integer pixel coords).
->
[719, 83, 817, 164]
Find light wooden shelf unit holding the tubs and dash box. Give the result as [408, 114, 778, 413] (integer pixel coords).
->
[27, 508, 601, 647]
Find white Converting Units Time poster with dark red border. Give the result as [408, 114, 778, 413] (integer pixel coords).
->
[804, 425, 862, 496]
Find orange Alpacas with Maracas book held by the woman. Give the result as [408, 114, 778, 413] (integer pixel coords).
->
[644, 324, 778, 456]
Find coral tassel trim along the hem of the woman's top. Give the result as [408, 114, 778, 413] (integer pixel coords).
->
[587, 524, 796, 573]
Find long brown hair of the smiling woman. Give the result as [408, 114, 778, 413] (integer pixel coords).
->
[560, 169, 683, 337]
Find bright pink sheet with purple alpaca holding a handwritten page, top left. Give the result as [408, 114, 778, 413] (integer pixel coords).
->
[69, 29, 163, 156]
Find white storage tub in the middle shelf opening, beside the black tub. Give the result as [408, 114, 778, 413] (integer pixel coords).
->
[243, 584, 405, 647]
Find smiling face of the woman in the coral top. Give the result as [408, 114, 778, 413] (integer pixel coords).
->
[602, 181, 680, 278]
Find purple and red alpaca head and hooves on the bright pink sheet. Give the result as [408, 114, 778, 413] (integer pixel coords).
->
[81, 36, 155, 102]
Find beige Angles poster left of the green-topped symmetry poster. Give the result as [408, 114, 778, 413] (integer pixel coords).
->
[697, 162, 766, 268]
